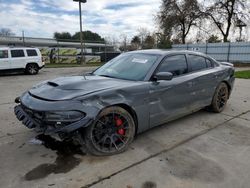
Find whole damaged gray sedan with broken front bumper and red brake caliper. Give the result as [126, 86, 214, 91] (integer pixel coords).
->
[15, 50, 234, 155]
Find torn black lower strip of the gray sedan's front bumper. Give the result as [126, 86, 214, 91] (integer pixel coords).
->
[14, 105, 93, 139]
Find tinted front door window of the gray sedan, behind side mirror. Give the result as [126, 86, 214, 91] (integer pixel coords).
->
[157, 55, 188, 76]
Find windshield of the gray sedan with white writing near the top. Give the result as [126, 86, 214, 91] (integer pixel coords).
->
[93, 53, 159, 81]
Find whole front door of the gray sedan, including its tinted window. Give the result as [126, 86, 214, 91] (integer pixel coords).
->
[150, 54, 194, 127]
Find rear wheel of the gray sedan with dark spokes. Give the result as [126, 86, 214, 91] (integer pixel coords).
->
[210, 82, 229, 113]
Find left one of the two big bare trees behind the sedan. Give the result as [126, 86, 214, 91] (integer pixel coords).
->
[157, 0, 202, 44]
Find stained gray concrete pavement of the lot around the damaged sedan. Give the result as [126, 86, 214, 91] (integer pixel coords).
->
[0, 67, 250, 188]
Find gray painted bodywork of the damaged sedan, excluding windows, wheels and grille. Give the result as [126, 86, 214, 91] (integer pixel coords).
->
[15, 50, 234, 136]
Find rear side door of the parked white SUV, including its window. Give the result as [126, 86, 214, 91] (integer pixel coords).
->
[10, 49, 26, 69]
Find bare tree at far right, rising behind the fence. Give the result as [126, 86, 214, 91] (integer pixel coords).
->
[203, 0, 248, 42]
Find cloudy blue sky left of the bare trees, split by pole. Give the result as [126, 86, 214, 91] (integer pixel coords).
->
[0, 0, 161, 38]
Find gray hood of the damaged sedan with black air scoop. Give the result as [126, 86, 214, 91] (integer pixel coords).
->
[29, 76, 131, 101]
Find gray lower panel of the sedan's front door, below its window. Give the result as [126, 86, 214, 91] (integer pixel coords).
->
[150, 72, 195, 127]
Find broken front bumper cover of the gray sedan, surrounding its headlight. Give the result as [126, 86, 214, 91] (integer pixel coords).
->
[14, 92, 100, 135]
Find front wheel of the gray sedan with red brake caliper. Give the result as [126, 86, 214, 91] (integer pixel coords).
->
[83, 106, 135, 156]
